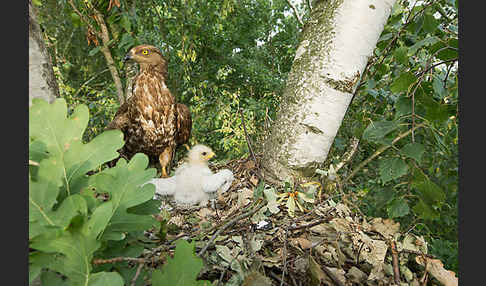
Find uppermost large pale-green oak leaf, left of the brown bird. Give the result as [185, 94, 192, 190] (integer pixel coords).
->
[29, 98, 124, 196]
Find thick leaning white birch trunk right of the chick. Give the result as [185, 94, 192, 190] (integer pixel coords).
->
[263, 0, 395, 180]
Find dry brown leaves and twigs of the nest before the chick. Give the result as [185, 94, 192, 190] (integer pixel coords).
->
[150, 155, 457, 286]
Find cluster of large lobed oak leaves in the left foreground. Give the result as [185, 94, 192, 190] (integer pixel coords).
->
[29, 99, 155, 285]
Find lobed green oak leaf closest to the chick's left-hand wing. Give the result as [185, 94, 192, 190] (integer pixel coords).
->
[90, 153, 156, 238]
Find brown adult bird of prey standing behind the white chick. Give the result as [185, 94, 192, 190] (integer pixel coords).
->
[107, 45, 192, 177]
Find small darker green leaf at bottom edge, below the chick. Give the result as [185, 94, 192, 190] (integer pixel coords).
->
[152, 240, 211, 286]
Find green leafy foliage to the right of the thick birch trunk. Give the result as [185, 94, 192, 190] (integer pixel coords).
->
[329, 0, 458, 271]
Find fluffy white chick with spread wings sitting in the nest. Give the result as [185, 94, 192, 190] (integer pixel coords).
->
[149, 145, 234, 205]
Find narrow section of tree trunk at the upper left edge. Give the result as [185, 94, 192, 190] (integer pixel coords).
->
[29, 1, 59, 106]
